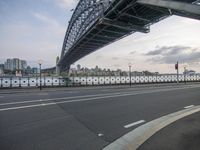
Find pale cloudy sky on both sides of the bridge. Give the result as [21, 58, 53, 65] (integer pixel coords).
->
[0, 0, 200, 73]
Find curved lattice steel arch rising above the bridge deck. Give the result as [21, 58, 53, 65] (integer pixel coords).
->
[61, 0, 110, 59]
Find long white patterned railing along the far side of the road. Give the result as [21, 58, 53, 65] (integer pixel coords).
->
[0, 75, 200, 88]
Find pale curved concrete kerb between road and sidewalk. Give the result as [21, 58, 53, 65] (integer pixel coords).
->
[102, 106, 200, 150]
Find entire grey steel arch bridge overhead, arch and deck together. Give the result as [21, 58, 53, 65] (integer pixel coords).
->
[57, 0, 200, 71]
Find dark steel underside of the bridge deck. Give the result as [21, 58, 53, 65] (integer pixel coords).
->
[58, 0, 199, 71]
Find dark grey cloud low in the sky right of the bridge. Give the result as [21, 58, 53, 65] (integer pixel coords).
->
[145, 46, 200, 64]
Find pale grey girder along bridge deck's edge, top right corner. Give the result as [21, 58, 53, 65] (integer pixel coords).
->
[137, 0, 200, 20]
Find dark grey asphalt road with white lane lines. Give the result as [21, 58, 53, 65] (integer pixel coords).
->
[0, 84, 200, 150]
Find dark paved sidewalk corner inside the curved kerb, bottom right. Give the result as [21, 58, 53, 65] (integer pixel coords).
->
[138, 112, 200, 150]
